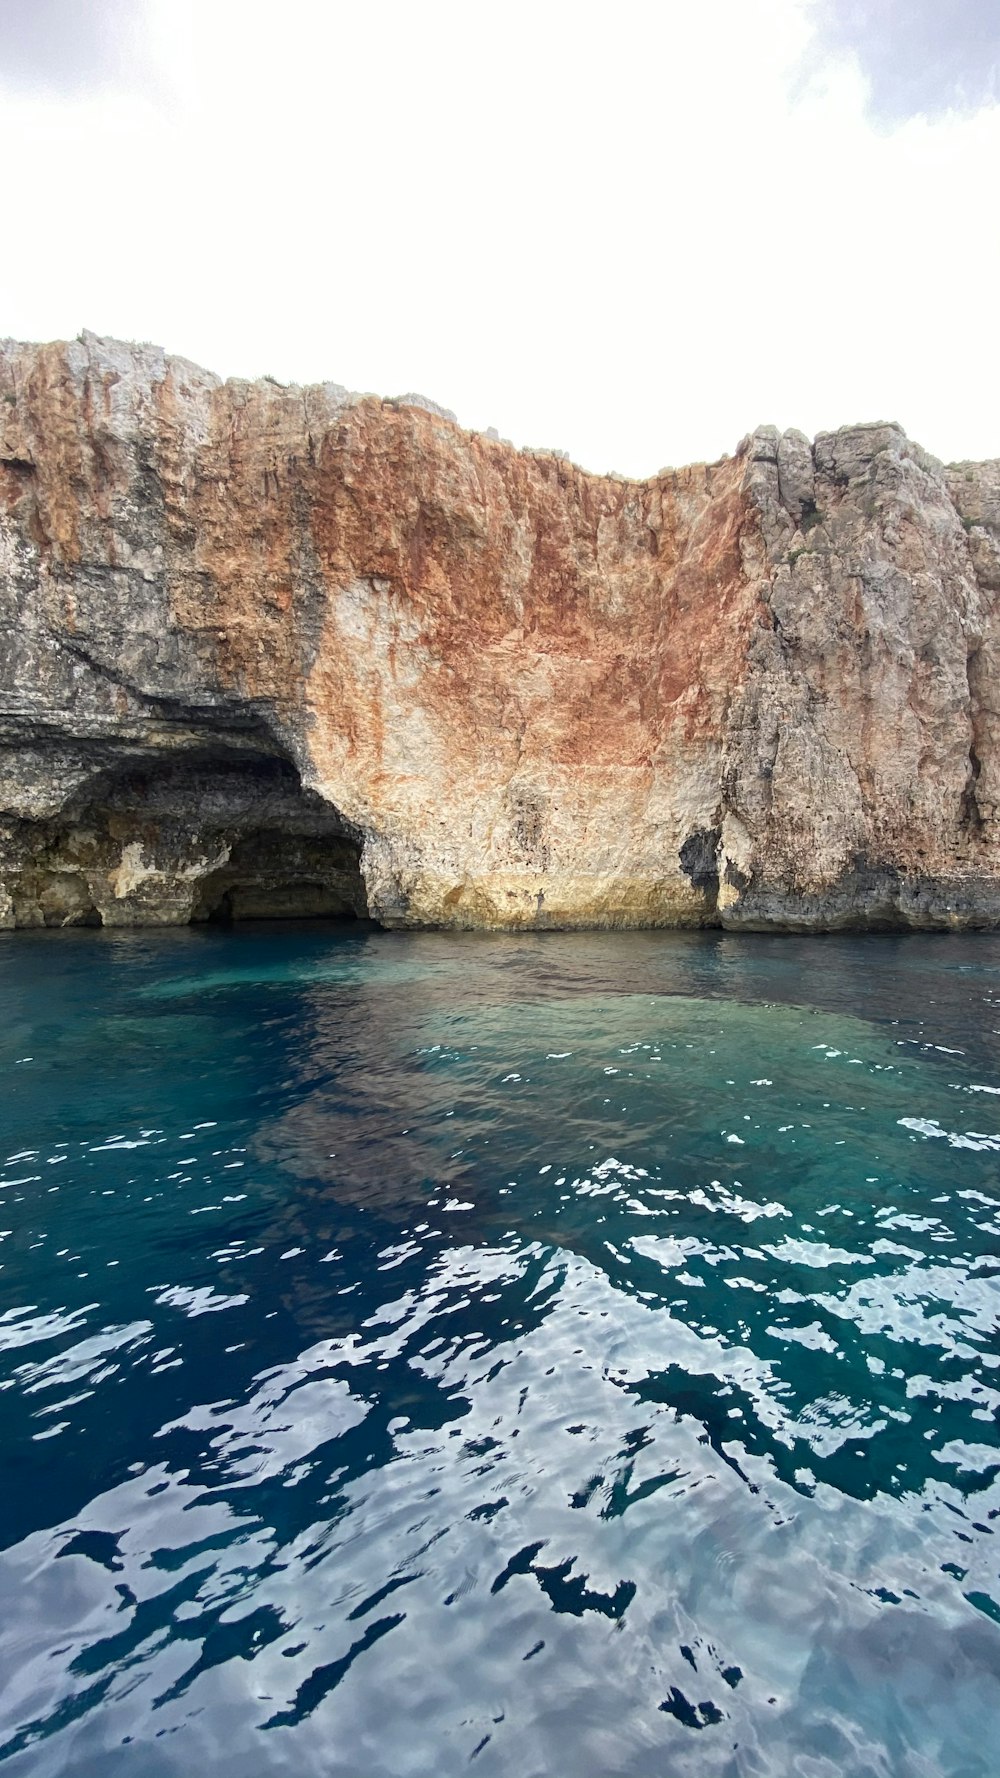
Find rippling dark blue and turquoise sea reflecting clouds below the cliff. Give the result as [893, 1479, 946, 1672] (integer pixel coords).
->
[0, 928, 1000, 1778]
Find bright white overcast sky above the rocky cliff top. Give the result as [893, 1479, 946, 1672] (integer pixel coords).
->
[0, 0, 1000, 475]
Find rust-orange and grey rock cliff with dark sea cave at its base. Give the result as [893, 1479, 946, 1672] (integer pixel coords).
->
[0, 334, 1000, 928]
